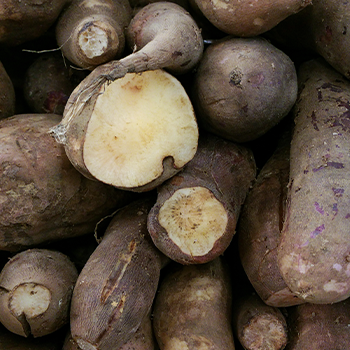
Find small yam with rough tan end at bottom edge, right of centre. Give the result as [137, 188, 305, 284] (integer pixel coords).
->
[232, 293, 288, 350]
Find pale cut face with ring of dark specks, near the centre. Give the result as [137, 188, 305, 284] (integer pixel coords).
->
[158, 187, 228, 256]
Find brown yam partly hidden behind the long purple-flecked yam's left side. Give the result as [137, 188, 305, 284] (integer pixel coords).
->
[237, 131, 303, 307]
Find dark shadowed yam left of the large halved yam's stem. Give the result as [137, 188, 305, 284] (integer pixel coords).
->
[23, 52, 86, 115]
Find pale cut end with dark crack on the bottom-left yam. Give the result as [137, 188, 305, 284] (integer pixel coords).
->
[9, 283, 51, 319]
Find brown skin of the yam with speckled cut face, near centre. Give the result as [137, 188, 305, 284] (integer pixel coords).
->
[148, 132, 256, 264]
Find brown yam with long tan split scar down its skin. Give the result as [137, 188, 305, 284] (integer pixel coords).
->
[70, 196, 167, 350]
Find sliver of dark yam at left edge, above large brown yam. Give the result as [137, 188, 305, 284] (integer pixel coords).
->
[0, 62, 16, 119]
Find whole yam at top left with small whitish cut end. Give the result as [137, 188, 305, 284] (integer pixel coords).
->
[55, 0, 132, 70]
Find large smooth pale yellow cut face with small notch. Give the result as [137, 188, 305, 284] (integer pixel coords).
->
[83, 70, 198, 188]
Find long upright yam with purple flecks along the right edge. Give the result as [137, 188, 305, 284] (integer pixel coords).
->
[277, 59, 350, 304]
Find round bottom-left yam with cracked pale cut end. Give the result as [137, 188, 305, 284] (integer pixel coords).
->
[0, 249, 78, 338]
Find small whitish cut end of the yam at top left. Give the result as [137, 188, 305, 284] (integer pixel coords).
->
[78, 23, 113, 59]
